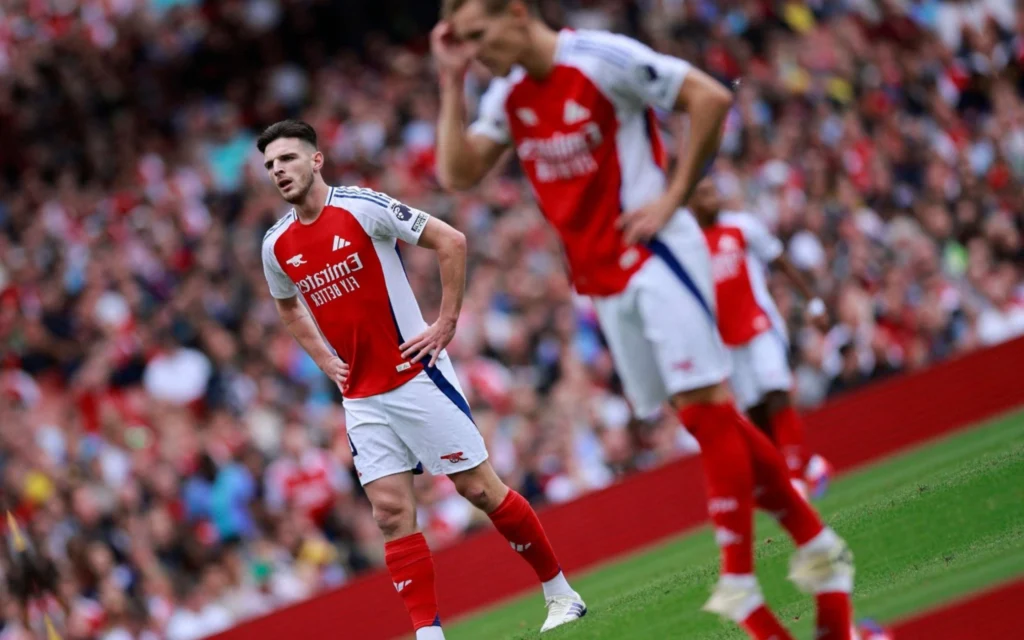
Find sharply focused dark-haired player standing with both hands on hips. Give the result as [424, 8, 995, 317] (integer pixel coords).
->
[257, 121, 587, 640]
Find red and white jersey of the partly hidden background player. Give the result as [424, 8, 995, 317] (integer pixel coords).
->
[705, 212, 782, 346]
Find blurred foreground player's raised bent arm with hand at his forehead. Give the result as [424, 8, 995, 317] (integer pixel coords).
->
[430, 20, 510, 190]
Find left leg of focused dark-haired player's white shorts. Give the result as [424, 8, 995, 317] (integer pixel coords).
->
[345, 396, 418, 486]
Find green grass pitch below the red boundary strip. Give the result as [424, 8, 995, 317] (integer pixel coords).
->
[445, 413, 1024, 640]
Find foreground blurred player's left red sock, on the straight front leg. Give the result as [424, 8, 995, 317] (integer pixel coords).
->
[679, 404, 754, 574]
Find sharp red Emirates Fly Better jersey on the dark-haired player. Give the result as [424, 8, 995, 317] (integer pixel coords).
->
[263, 187, 430, 397]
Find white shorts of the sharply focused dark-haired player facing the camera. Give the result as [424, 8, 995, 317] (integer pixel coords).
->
[344, 354, 487, 485]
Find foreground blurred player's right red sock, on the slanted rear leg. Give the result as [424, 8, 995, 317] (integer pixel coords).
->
[730, 406, 824, 545]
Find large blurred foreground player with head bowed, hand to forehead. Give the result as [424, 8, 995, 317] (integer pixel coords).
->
[431, 0, 853, 640]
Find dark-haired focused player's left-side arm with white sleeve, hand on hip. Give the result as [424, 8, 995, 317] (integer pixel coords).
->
[263, 233, 348, 388]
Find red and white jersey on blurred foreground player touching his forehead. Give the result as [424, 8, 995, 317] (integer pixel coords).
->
[470, 31, 690, 296]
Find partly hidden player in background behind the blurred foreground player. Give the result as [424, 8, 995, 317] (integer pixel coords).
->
[690, 178, 828, 497]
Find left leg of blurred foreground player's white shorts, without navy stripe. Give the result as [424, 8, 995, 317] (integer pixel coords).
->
[594, 291, 668, 418]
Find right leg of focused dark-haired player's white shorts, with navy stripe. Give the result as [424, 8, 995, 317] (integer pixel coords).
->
[385, 366, 487, 475]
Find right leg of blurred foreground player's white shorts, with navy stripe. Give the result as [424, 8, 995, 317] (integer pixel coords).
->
[638, 248, 731, 394]
